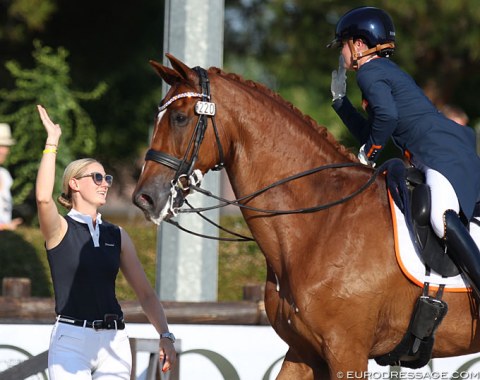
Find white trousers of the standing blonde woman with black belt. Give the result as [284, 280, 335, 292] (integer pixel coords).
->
[48, 322, 132, 380]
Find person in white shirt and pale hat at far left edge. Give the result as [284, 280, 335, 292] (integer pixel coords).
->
[0, 123, 23, 231]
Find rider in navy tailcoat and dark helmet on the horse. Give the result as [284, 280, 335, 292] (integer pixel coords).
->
[328, 7, 480, 296]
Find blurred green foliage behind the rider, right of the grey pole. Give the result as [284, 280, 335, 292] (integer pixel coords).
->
[225, 0, 480, 146]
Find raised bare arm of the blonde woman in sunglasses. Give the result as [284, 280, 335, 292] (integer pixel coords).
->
[35, 105, 67, 248]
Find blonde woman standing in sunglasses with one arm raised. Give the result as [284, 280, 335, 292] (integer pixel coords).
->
[36, 106, 176, 380]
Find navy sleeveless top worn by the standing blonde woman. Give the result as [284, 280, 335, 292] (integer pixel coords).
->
[47, 215, 123, 321]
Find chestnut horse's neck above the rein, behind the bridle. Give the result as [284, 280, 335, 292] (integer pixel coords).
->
[222, 81, 351, 196]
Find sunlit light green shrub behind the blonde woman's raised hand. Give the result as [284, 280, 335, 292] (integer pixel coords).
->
[0, 42, 106, 218]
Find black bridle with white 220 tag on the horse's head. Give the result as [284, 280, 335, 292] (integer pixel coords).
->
[145, 66, 224, 190]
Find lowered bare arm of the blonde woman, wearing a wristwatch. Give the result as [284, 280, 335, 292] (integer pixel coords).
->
[120, 228, 177, 371]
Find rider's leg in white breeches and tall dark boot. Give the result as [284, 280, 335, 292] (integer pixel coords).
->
[425, 169, 480, 296]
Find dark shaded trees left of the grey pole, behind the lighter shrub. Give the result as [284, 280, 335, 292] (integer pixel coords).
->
[0, 0, 164, 168]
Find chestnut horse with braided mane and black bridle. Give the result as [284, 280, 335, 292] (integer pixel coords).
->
[133, 54, 479, 380]
